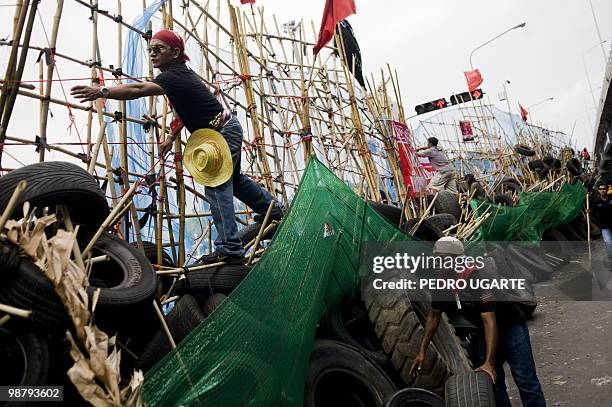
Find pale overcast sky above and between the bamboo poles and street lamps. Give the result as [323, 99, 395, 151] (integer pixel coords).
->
[0, 0, 612, 169]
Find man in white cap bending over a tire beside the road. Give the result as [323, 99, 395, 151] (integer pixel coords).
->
[411, 236, 546, 407]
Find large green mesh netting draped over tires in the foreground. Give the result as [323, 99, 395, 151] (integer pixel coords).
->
[144, 158, 410, 407]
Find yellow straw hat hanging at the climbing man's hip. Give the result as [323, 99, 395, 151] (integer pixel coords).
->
[183, 129, 234, 187]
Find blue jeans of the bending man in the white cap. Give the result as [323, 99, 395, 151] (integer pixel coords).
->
[479, 323, 546, 407]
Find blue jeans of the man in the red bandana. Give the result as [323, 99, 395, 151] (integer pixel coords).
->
[205, 116, 273, 256]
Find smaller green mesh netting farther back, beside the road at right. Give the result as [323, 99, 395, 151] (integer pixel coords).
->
[470, 183, 586, 242]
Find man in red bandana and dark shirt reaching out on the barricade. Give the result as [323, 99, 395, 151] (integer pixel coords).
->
[71, 30, 283, 263]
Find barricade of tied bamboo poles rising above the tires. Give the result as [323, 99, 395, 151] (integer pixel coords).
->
[0, 0, 584, 270]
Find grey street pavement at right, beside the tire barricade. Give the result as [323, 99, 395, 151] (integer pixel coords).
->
[506, 246, 612, 407]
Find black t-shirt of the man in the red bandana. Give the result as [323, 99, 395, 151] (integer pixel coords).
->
[153, 62, 223, 133]
